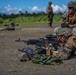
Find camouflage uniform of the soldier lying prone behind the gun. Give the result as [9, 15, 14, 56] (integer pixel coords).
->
[58, 28, 76, 60]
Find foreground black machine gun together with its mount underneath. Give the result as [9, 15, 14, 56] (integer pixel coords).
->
[15, 35, 59, 55]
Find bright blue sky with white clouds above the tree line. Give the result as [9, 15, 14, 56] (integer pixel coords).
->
[0, 0, 76, 14]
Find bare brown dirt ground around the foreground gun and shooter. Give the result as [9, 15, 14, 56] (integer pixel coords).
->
[0, 25, 76, 75]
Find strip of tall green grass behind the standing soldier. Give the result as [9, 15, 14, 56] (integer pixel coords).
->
[0, 15, 61, 24]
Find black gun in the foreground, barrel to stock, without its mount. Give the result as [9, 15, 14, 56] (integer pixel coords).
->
[15, 34, 59, 50]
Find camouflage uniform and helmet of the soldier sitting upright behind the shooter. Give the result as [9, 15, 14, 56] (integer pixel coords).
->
[62, 1, 76, 25]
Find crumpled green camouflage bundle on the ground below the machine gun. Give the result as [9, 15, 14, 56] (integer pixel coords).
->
[32, 54, 62, 65]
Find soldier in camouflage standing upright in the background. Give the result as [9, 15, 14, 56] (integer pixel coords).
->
[46, 2, 54, 27]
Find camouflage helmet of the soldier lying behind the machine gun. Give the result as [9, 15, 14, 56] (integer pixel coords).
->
[57, 28, 72, 36]
